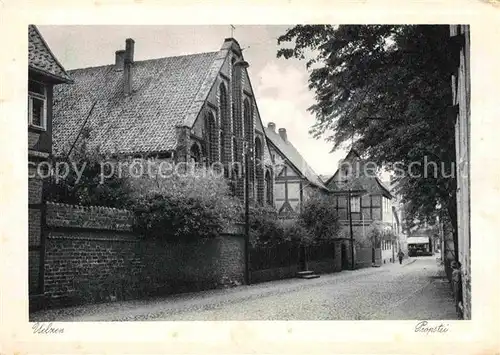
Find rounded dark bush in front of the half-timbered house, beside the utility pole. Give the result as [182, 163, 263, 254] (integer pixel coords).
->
[298, 193, 340, 240]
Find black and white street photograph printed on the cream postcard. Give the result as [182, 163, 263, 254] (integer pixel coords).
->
[26, 24, 472, 326]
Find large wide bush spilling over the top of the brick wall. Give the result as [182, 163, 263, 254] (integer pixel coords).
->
[130, 163, 242, 241]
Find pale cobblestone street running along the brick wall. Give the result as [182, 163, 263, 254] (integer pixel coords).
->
[30, 256, 457, 321]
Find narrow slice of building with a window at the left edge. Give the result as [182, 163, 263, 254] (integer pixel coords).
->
[28, 25, 72, 304]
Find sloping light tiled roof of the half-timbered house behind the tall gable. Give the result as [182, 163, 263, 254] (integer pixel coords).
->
[264, 127, 326, 189]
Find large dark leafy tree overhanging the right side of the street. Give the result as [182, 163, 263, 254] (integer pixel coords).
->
[278, 25, 457, 256]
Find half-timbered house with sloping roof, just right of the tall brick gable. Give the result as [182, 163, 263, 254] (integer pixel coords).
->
[265, 122, 328, 218]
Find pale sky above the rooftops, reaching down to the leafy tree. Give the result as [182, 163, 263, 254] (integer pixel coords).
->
[38, 25, 346, 175]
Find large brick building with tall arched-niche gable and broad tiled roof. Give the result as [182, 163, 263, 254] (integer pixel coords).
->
[54, 38, 273, 204]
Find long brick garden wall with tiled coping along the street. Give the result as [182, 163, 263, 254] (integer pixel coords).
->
[44, 203, 244, 306]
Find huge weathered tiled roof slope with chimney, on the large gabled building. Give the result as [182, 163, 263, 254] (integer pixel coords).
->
[53, 52, 223, 154]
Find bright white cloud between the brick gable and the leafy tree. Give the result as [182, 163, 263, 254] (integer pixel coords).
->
[254, 62, 345, 174]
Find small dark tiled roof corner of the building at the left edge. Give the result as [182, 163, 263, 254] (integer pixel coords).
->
[28, 25, 72, 82]
